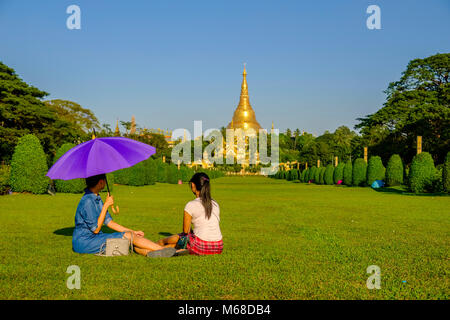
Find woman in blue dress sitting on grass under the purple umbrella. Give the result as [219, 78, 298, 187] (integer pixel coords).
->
[72, 174, 176, 257]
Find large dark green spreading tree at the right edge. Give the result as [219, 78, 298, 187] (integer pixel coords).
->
[355, 53, 450, 162]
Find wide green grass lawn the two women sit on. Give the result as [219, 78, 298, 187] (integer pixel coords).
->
[0, 177, 450, 299]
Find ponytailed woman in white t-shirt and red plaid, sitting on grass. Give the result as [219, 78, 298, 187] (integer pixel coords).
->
[158, 172, 223, 255]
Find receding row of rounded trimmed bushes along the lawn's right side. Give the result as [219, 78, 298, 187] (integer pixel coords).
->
[272, 152, 450, 193]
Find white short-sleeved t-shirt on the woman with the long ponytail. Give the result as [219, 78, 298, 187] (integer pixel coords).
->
[184, 198, 222, 241]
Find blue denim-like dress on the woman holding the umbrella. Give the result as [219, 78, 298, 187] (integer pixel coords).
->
[72, 189, 124, 253]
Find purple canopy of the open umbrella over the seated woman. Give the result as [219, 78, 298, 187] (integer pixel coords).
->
[47, 137, 156, 180]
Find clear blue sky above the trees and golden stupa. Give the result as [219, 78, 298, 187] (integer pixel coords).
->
[0, 0, 450, 135]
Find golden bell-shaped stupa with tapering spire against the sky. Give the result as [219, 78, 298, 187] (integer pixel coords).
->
[227, 66, 261, 133]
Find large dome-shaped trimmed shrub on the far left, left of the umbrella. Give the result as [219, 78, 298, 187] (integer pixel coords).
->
[10, 134, 49, 194]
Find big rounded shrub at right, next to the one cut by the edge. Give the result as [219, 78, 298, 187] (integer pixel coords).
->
[408, 152, 436, 193]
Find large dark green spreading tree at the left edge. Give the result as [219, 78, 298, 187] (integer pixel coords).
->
[0, 62, 82, 164]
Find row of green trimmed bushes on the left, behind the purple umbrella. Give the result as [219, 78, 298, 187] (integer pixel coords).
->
[0, 135, 223, 195]
